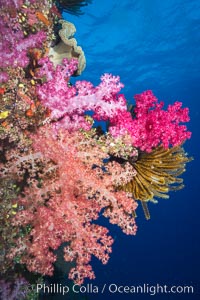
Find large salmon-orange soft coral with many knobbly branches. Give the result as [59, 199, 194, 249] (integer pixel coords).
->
[9, 126, 137, 284]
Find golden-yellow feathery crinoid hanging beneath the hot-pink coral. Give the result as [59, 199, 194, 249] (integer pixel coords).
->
[120, 146, 193, 219]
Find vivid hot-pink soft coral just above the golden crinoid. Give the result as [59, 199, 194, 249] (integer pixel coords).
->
[110, 91, 191, 152]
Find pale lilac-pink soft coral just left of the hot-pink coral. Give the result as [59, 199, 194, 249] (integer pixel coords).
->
[37, 58, 126, 130]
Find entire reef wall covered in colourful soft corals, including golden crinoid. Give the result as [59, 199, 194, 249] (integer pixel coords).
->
[0, 0, 191, 299]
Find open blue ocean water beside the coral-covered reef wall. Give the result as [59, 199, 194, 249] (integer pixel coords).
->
[64, 0, 200, 300]
